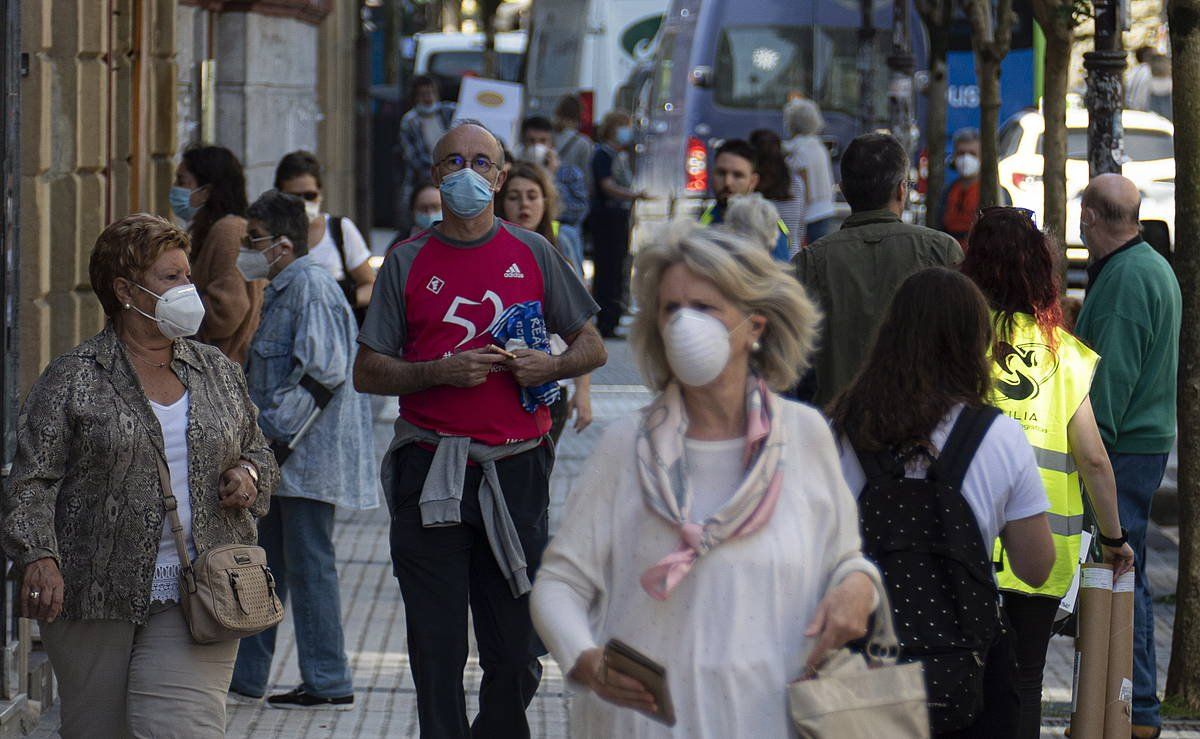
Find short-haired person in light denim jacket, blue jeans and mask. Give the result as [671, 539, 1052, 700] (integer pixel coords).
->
[229, 190, 379, 710]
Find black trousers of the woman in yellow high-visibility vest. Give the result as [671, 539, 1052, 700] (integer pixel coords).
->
[1004, 591, 1058, 739]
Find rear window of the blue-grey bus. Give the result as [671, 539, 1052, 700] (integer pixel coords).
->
[714, 25, 812, 110]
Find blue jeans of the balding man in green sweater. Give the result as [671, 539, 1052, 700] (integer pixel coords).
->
[1109, 451, 1166, 726]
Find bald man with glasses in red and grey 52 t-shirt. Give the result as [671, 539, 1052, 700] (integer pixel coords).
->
[354, 122, 606, 738]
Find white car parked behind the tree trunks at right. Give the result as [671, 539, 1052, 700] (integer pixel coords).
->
[998, 107, 1175, 277]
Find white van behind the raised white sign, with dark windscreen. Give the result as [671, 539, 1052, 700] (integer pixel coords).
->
[413, 31, 528, 100]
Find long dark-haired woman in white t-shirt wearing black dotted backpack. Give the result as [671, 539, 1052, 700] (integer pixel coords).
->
[830, 268, 1055, 739]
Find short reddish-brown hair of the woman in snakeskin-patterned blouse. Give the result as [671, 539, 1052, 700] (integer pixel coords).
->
[88, 214, 192, 317]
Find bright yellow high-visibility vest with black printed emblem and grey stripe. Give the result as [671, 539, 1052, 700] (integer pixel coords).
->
[991, 312, 1100, 597]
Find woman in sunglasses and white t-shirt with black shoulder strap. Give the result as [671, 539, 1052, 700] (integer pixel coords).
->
[275, 149, 376, 325]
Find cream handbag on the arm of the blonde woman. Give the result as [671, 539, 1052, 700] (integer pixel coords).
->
[787, 584, 930, 739]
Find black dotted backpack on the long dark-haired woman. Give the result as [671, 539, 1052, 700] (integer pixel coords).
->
[856, 407, 1003, 732]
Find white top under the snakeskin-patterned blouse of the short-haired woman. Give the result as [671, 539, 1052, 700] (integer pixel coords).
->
[150, 390, 196, 603]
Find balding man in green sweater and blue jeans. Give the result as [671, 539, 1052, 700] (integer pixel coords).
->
[1075, 174, 1182, 739]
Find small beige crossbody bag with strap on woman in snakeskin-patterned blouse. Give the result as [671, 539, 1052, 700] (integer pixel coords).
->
[155, 455, 283, 644]
